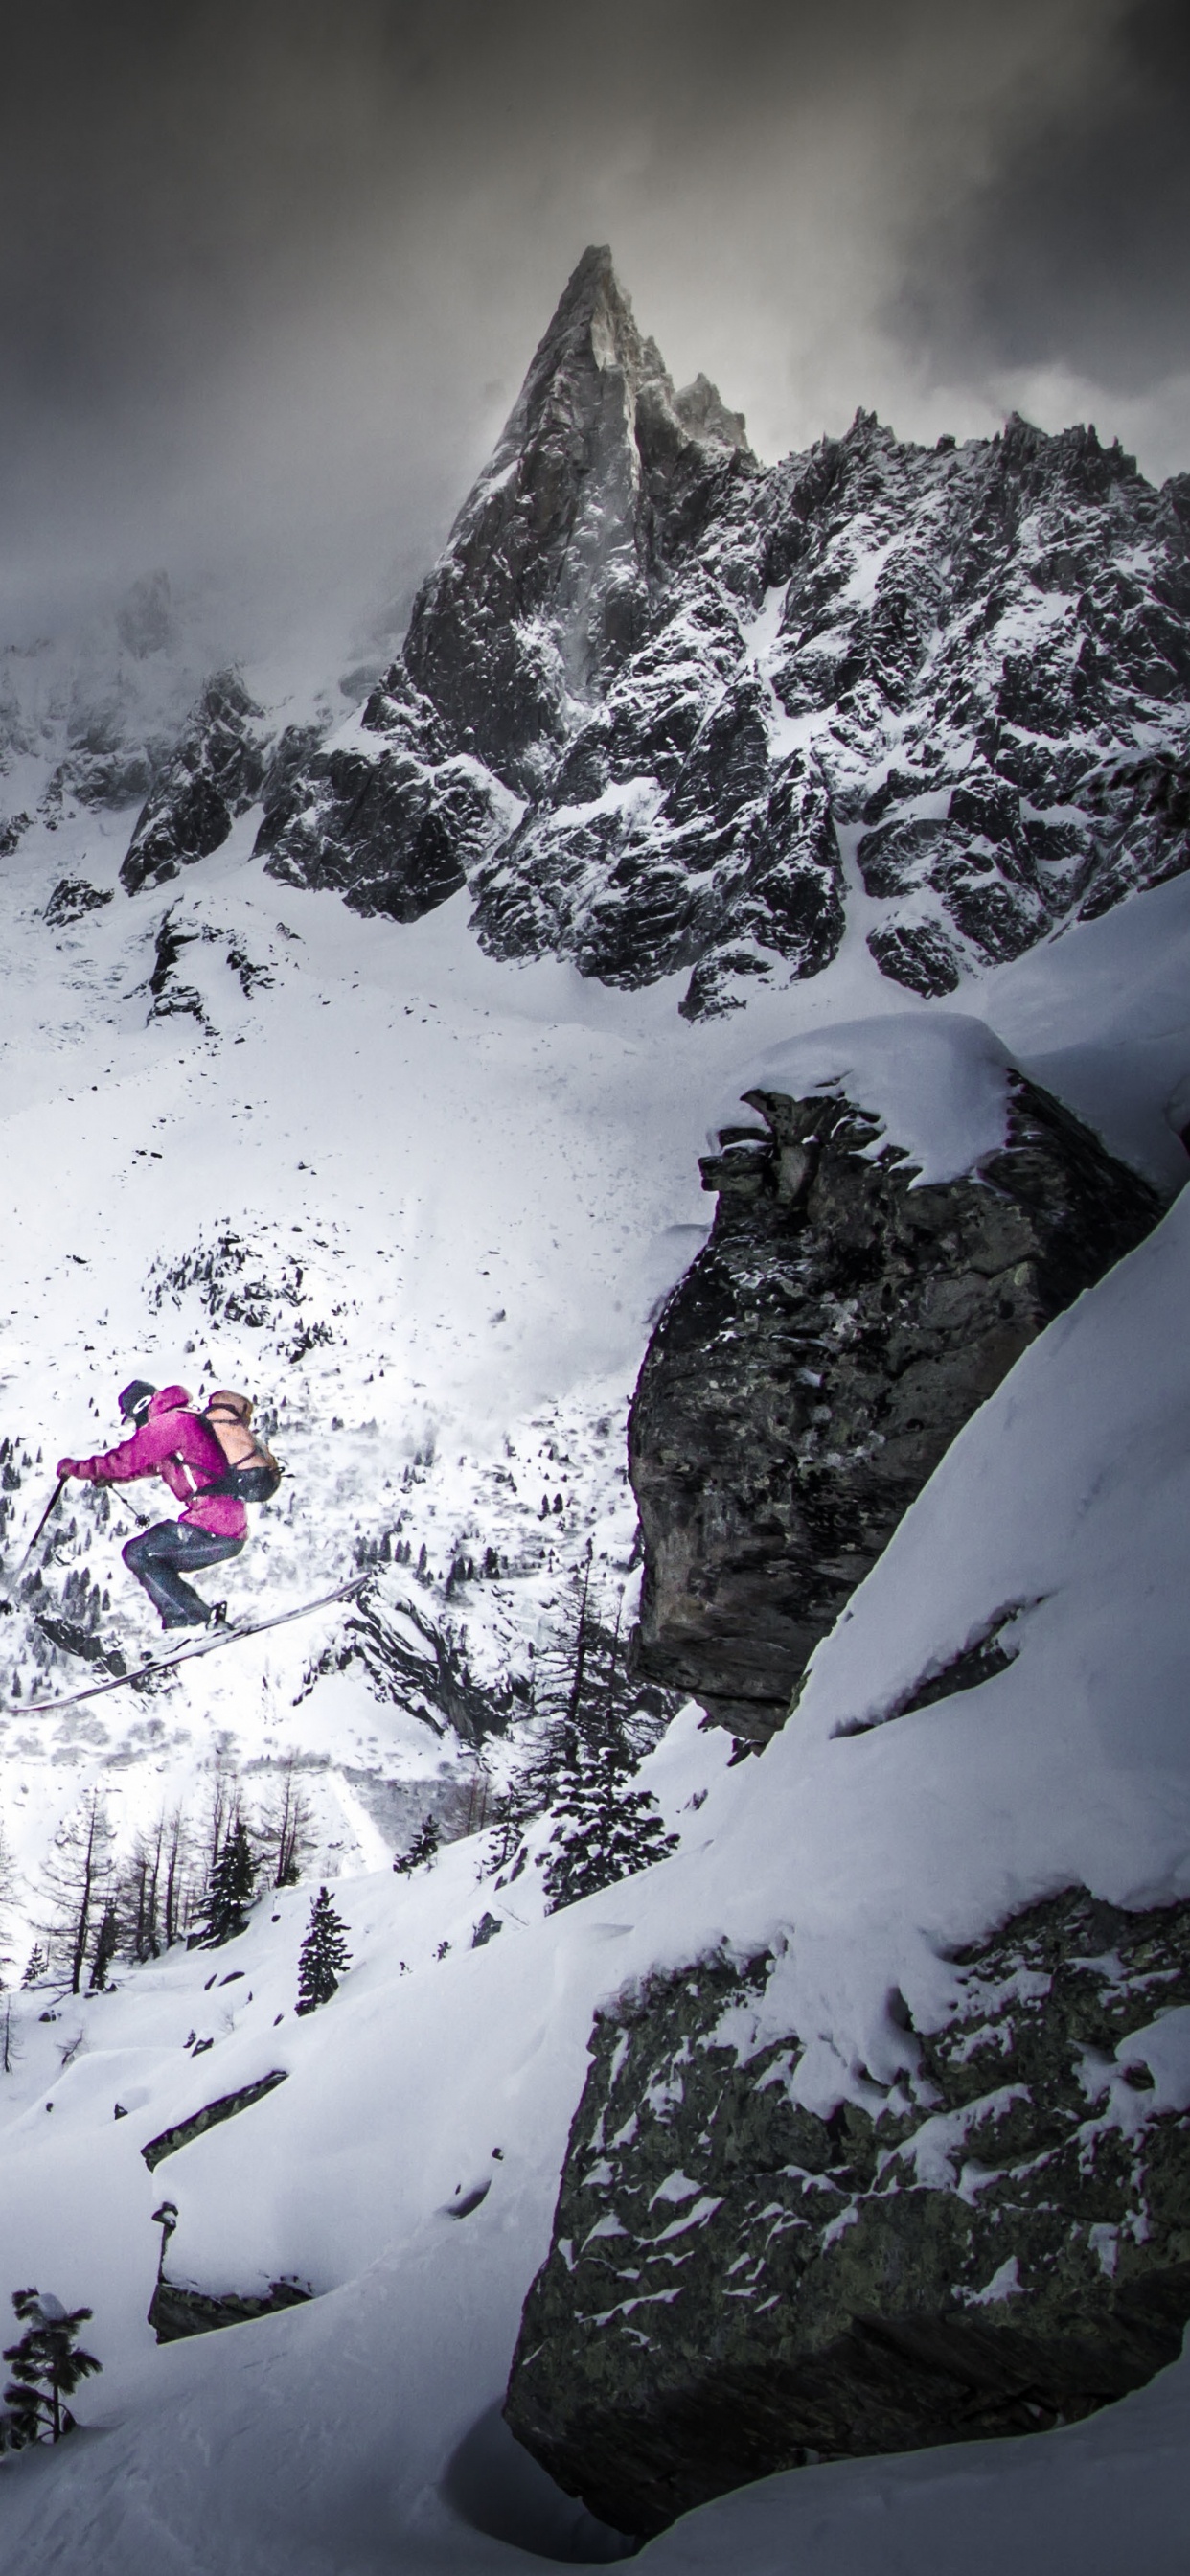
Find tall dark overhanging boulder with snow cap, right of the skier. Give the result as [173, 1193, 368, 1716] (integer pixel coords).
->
[629, 1074, 1161, 1741]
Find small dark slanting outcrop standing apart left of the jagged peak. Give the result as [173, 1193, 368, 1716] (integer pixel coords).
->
[121, 670, 265, 894]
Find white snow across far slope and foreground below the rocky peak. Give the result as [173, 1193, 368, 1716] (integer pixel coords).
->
[0, 751, 1190, 2576]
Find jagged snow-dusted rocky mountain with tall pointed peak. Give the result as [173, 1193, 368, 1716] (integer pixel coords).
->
[243, 250, 1190, 1015]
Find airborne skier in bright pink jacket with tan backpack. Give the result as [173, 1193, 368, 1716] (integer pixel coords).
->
[57, 1378, 252, 1628]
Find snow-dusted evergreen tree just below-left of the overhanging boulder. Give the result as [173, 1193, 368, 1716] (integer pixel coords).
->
[543, 1718, 680, 1914]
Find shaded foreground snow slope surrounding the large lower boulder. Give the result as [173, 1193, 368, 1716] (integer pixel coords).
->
[0, 1159, 1190, 2576]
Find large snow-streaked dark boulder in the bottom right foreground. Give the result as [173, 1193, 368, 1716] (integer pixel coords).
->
[505, 1888, 1190, 2535]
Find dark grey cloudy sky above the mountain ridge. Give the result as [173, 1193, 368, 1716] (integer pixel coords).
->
[0, 0, 1190, 633]
